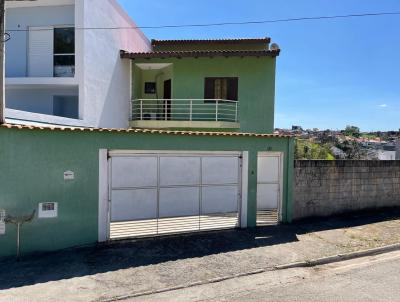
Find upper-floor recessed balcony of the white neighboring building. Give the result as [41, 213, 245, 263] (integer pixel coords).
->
[5, 0, 78, 88]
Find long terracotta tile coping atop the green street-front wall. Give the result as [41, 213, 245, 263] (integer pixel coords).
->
[0, 124, 293, 138]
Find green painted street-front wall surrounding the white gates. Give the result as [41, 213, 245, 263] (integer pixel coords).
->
[0, 128, 293, 256]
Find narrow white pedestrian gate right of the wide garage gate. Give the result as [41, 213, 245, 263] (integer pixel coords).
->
[257, 152, 282, 225]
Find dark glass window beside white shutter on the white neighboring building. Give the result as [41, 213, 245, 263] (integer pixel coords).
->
[54, 27, 75, 77]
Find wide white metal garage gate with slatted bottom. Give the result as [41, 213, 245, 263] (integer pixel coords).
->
[109, 152, 241, 239]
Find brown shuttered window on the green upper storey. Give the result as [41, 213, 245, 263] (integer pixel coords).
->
[204, 78, 239, 102]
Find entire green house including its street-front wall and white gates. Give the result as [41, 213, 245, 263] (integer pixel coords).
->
[0, 38, 293, 256]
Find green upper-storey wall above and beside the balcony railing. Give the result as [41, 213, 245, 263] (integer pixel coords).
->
[133, 57, 276, 133]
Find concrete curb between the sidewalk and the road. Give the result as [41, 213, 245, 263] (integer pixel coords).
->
[98, 243, 400, 302]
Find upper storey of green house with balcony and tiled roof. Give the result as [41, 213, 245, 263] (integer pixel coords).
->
[121, 38, 279, 133]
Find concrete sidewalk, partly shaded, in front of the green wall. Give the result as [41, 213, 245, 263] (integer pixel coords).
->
[0, 209, 400, 301]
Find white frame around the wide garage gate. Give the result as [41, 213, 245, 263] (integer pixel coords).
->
[98, 149, 249, 242]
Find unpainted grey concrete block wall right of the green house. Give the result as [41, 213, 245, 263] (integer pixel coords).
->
[293, 160, 400, 220]
